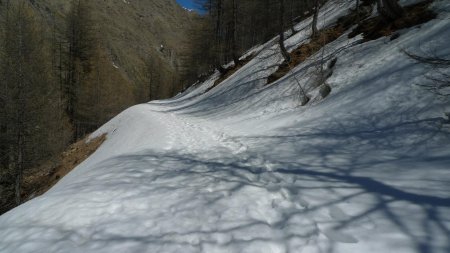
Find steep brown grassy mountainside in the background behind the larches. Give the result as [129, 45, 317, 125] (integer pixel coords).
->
[29, 0, 195, 116]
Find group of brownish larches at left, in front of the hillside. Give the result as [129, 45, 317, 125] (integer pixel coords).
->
[0, 0, 95, 204]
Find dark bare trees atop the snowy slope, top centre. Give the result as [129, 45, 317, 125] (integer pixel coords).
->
[186, 0, 325, 73]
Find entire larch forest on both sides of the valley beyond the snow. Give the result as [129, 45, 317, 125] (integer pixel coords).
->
[0, 0, 442, 212]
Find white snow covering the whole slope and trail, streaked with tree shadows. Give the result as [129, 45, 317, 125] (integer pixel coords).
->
[0, 1, 450, 253]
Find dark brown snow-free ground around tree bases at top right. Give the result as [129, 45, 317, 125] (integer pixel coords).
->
[349, 0, 436, 41]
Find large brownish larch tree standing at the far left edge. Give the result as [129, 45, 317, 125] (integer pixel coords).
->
[0, 0, 69, 204]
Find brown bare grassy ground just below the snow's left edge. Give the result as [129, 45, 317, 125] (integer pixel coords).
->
[0, 135, 106, 214]
